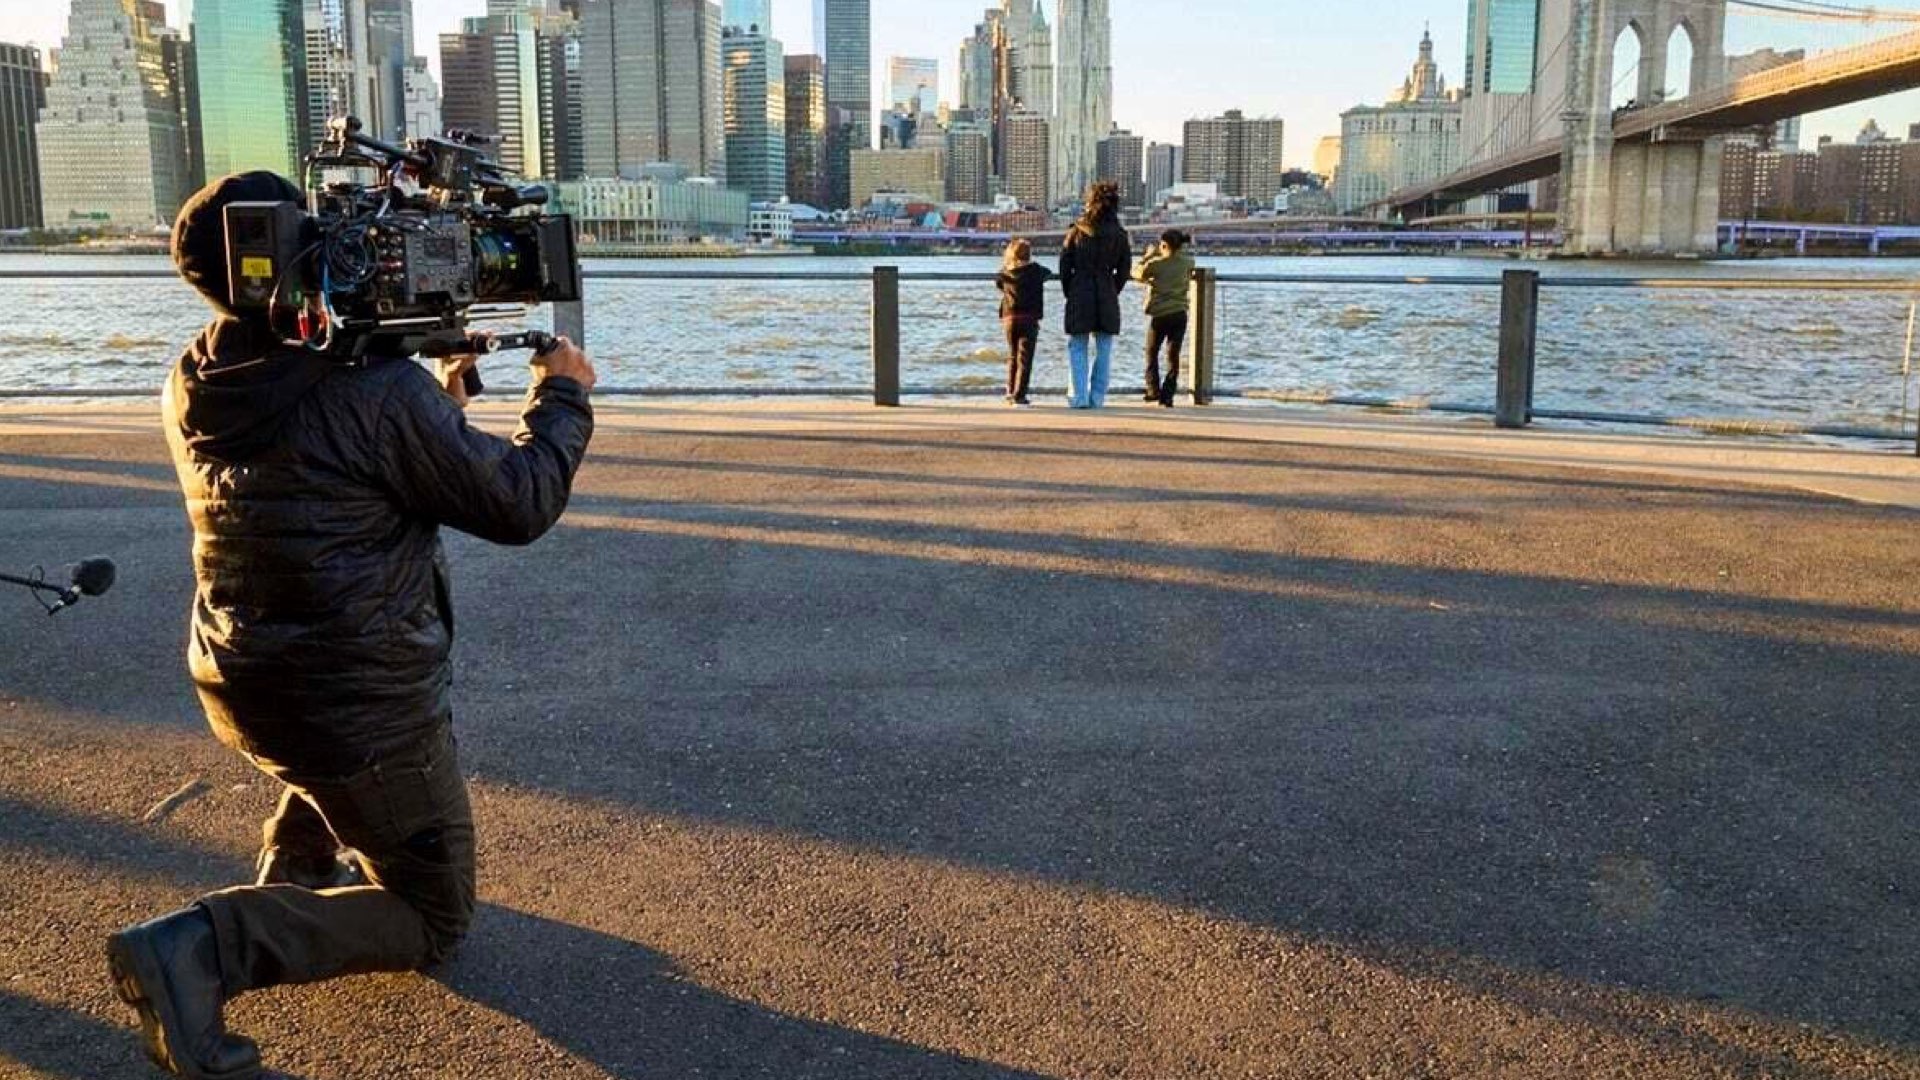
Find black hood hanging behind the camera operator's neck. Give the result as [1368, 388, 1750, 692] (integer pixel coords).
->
[169, 319, 334, 461]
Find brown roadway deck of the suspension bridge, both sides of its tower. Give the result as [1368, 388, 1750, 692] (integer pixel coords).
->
[1386, 31, 1920, 213]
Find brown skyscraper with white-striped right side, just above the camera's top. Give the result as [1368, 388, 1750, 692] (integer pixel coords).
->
[440, 15, 547, 177]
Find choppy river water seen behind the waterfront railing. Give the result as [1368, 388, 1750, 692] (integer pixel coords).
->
[0, 254, 1920, 429]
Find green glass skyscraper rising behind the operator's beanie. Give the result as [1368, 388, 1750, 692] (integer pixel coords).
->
[194, 0, 307, 177]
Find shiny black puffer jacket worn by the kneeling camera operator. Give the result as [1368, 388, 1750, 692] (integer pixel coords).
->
[163, 319, 593, 771]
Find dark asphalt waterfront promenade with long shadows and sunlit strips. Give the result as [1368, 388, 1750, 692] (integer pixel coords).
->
[0, 402, 1920, 1080]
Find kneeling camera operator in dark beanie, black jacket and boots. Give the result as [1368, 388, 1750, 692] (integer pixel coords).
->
[108, 173, 595, 1080]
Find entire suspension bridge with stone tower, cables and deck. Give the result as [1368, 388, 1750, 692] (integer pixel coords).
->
[1386, 0, 1920, 254]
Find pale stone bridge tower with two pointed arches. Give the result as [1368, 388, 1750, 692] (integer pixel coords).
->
[1561, 0, 1726, 256]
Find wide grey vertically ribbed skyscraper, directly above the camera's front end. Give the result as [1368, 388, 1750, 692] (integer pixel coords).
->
[572, 0, 726, 181]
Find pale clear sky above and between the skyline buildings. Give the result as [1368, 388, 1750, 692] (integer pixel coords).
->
[0, 0, 1920, 165]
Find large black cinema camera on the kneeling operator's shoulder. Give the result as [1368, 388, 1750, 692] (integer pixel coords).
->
[227, 117, 580, 359]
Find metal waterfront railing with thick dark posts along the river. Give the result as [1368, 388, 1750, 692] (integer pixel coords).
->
[0, 267, 1920, 454]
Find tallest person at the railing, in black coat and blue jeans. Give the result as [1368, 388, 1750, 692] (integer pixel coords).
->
[1060, 181, 1133, 409]
